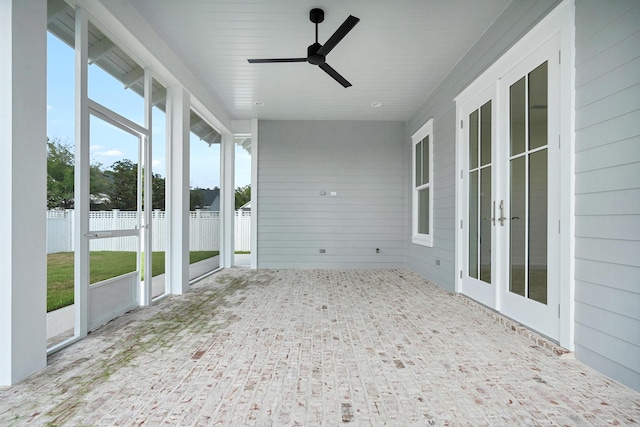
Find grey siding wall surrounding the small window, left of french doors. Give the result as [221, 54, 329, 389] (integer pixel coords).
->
[405, 0, 559, 291]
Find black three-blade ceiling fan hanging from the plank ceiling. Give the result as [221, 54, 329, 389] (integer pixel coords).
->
[247, 8, 360, 88]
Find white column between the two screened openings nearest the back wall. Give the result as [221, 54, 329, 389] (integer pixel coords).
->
[220, 133, 236, 268]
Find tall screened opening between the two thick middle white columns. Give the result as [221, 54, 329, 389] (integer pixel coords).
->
[189, 110, 221, 279]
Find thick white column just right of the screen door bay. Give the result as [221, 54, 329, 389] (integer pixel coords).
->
[165, 87, 190, 294]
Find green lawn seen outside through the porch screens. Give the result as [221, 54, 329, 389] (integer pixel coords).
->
[47, 251, 218, 312]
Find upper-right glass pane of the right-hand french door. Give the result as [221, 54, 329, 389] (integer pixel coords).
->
[529, 62, 547, 150]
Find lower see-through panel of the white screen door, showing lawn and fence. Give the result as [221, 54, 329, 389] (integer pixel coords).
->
[89, 236, 138, 284]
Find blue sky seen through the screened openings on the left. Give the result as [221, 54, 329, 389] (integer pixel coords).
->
[47, 33, 251, 188]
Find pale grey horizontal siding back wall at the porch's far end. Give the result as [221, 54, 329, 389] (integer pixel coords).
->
[257, 120, 406, 268]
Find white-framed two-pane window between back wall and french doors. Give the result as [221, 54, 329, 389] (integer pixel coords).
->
[411, 119, 433, 246]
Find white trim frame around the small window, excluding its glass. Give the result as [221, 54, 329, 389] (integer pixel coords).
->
[411, 118, 434, 247]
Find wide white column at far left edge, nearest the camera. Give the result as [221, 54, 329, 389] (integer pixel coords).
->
[0, 0, 47, 387]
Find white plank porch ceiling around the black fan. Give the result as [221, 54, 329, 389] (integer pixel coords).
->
[130, 0, 510, 120]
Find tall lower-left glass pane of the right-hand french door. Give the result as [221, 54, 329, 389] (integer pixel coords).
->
[508, 156, 527, 296]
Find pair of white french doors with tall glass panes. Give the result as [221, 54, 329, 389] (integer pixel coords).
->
[459, 35, 560, 339]
